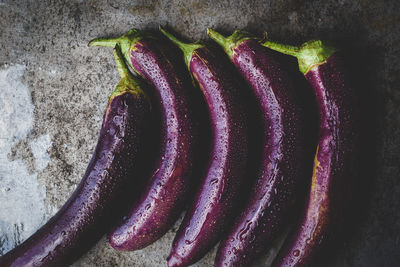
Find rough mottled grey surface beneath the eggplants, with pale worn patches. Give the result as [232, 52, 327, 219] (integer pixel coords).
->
[0, 0, 400, 266]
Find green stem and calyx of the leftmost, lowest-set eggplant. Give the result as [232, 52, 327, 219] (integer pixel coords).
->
[109, 44, 145, 102]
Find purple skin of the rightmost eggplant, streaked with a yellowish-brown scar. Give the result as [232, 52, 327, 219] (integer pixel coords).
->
[273, 53, 358, 266]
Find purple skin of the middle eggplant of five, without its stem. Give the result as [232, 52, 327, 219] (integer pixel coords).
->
[168, 47, 248, 267]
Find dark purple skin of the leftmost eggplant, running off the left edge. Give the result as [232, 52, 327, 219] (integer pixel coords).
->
[0, 93, 149, 267]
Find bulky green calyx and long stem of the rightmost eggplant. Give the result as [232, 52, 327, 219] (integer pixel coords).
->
[262, 40, 336, 74]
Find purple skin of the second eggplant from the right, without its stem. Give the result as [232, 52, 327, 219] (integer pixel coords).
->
[215, 39, 306, 267]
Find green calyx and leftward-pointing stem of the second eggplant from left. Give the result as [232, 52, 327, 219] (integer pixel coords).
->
[88, 29, 151, 73]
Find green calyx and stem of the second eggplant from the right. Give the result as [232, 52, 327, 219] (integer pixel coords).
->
[207, 28, 257, 59]
